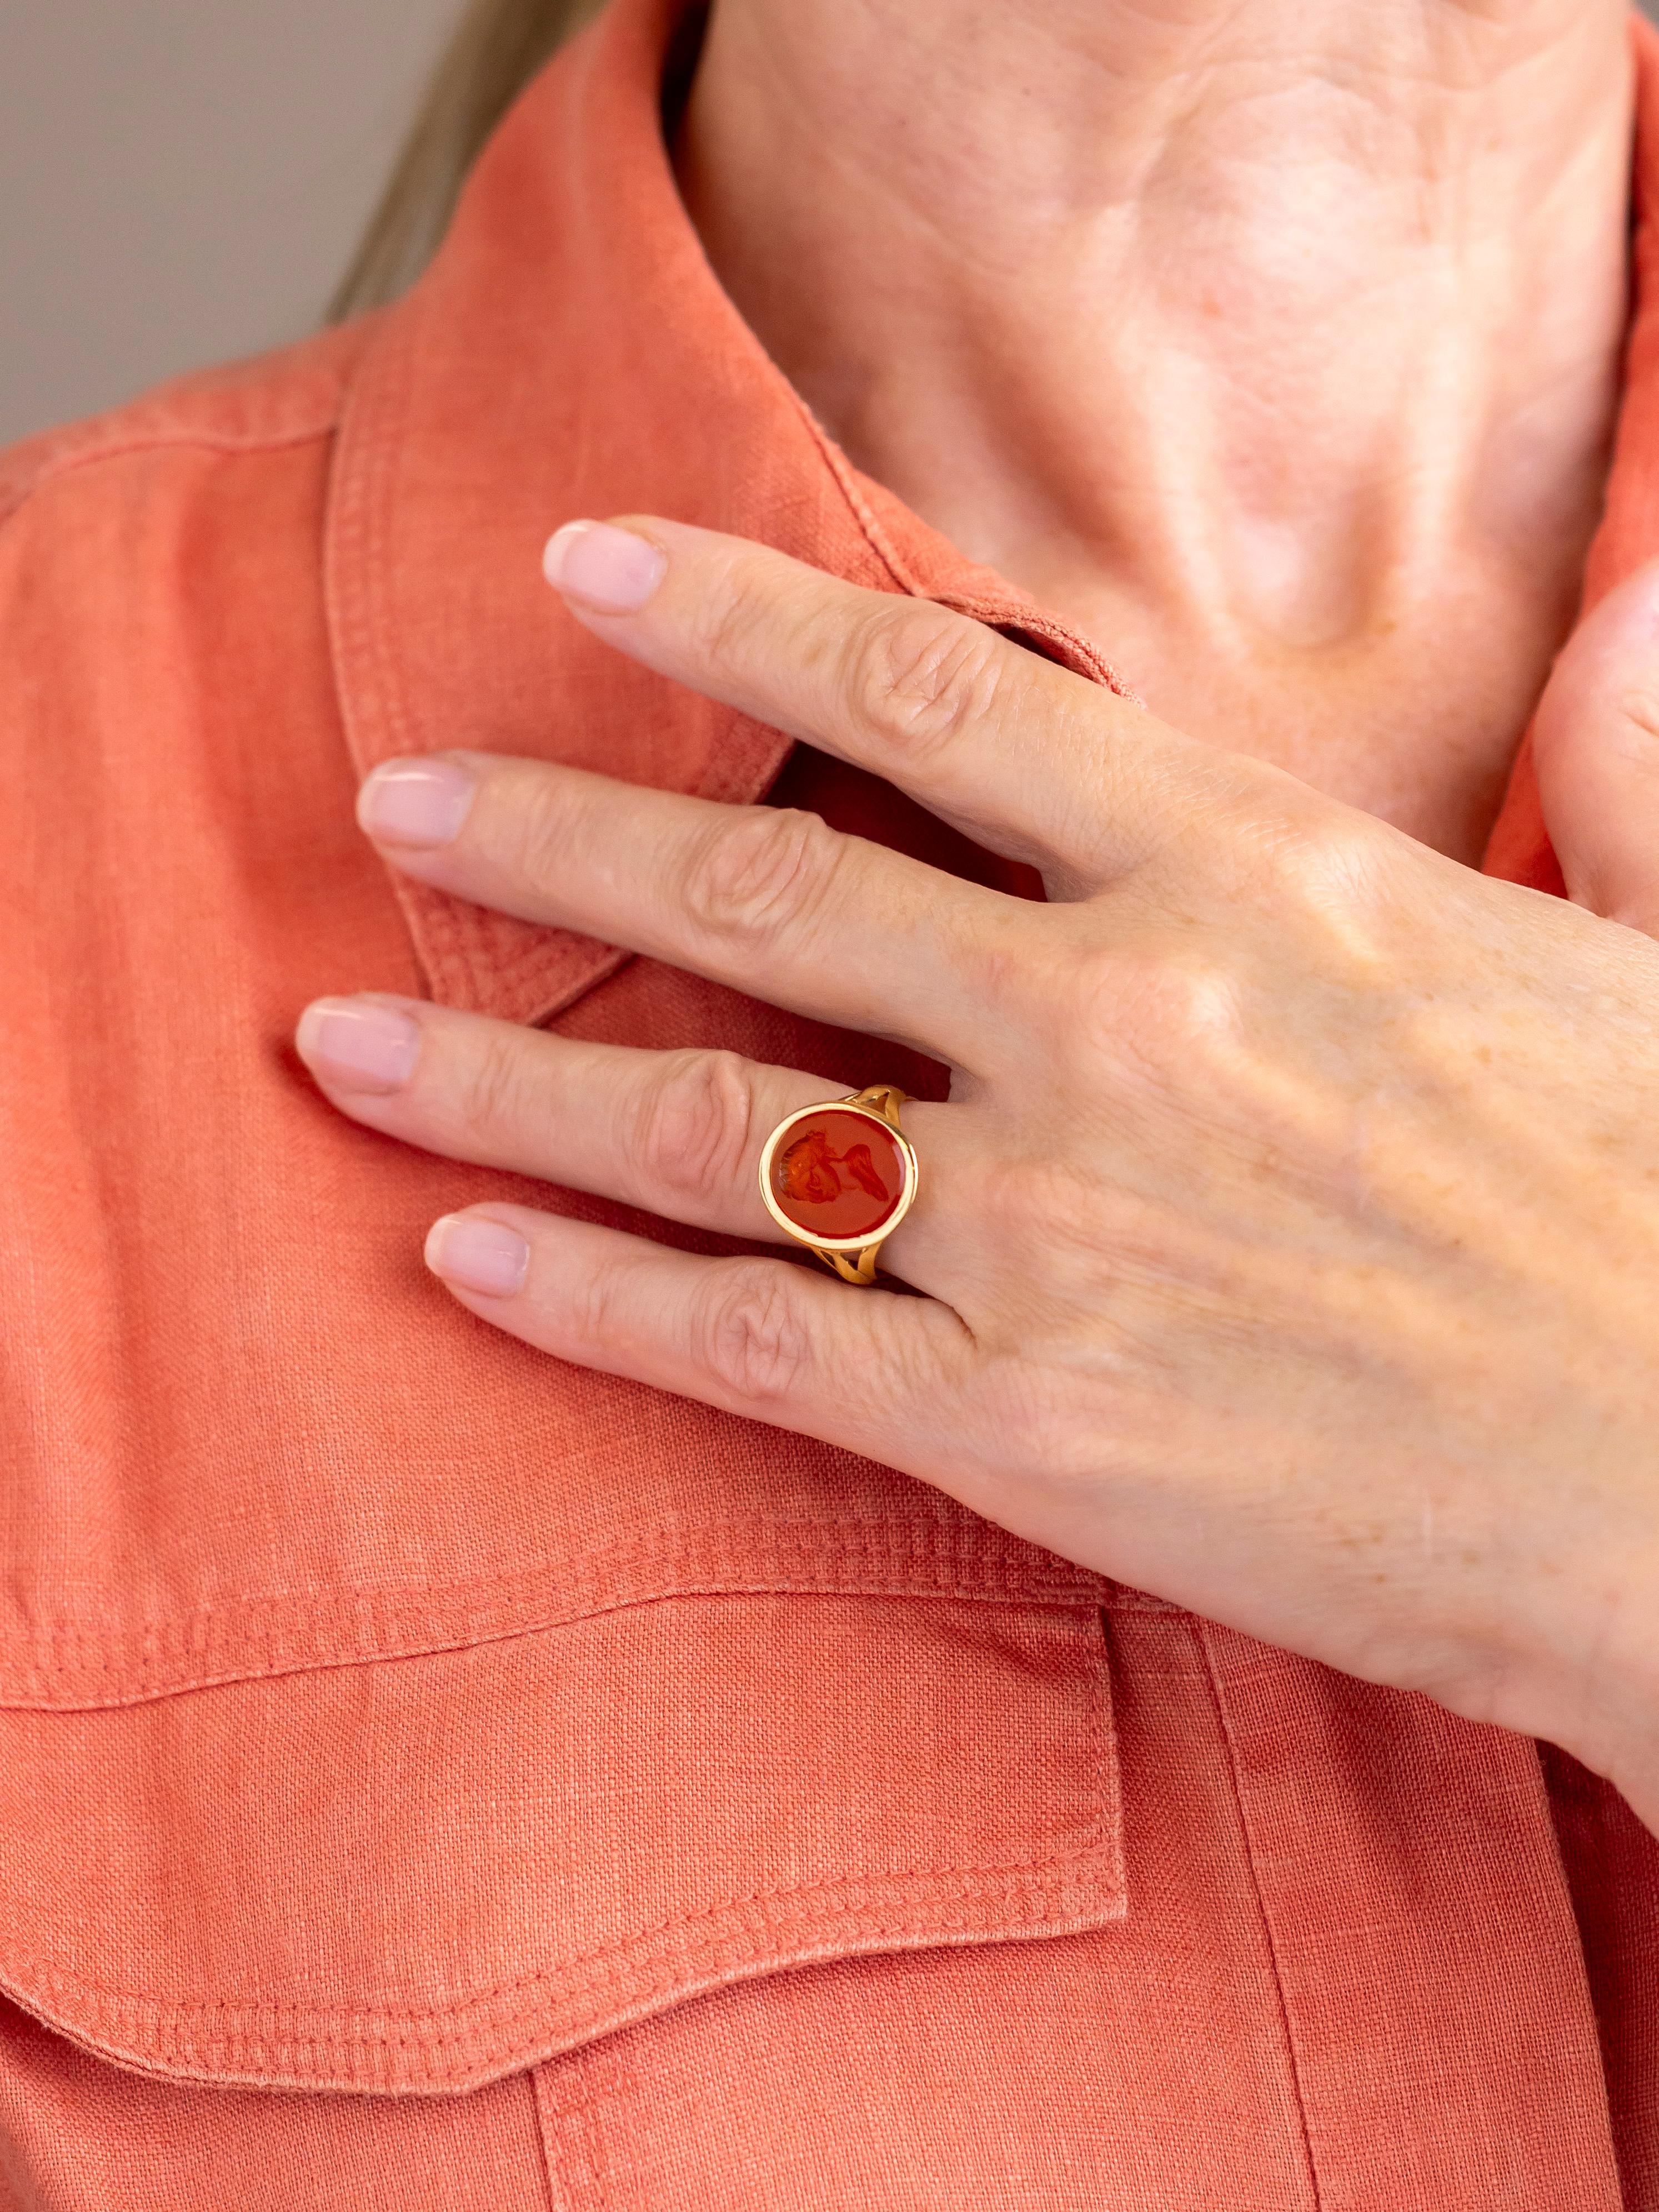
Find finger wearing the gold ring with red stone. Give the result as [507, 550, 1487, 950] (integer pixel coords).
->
[297, 993, 960, 1290]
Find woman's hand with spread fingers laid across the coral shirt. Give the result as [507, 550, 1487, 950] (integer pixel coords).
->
[299, 518, 1659, 1829]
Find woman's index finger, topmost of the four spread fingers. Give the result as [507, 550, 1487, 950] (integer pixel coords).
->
[547, 516, 1227, 885]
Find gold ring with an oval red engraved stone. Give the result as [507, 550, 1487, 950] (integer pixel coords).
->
[761, 1084, 918, 1285]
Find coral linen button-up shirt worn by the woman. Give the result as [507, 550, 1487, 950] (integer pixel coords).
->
[0, 0, 1659, 2212]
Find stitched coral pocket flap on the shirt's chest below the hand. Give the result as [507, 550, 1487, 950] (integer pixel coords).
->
[0, 1593, 1124, 2090]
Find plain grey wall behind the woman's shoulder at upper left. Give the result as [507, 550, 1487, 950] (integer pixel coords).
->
[0, 0, 1659, 444]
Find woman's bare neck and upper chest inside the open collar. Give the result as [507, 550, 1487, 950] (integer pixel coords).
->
[679, 0, 1632, 849]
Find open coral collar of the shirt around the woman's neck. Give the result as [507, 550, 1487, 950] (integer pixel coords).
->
[327, 0, 1659, 1022]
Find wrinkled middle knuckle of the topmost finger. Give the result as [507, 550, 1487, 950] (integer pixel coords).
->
[845, 599, 1011, 754]
